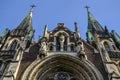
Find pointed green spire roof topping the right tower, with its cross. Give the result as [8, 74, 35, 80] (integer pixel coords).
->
[86, 6, 104, 32]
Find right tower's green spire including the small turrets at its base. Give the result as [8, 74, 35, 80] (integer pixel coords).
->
[86, 7, 110, 43]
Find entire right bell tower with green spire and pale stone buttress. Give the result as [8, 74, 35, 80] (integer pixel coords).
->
[86, 7, 120, 80]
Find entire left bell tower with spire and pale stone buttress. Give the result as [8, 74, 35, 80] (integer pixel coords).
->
[0, 8, 34, 80]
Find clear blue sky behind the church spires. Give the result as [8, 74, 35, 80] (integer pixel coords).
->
[0, 0, 120, 41]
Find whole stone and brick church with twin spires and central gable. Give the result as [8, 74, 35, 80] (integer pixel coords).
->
[0, 9, 120, 80]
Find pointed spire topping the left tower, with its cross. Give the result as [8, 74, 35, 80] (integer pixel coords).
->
[10, 5, 35, 36]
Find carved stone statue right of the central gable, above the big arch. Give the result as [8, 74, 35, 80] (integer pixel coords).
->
[76, 41, 85, 57]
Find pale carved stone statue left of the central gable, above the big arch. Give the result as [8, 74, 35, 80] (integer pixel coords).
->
[39, 38, 47, 57]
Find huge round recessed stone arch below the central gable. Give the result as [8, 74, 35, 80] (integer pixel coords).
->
[21, 54, 103, 80]
